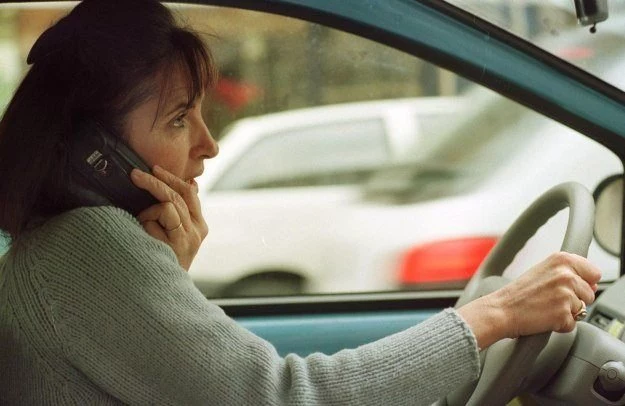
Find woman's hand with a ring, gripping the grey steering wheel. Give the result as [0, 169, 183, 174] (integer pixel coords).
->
[458, 252, 601, 349]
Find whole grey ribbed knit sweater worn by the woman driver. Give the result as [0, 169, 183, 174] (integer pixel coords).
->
[0, 207, 479, 406]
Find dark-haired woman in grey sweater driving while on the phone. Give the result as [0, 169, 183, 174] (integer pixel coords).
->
[0, 0, 600, 405]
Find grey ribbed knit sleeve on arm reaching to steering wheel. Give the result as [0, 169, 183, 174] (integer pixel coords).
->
[40, 207, 479, 406]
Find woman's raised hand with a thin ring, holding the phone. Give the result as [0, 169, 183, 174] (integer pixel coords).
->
[130, 165, 208, 271]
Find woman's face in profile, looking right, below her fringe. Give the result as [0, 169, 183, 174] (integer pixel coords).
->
[124, 69, 219, 182]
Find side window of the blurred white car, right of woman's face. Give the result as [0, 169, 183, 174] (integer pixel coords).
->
[214, 119, 389, 190]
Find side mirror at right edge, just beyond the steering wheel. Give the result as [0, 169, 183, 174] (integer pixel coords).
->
[593, 174, 623, 256]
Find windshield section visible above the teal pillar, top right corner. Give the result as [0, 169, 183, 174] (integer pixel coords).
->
[446, 0, 625, 90]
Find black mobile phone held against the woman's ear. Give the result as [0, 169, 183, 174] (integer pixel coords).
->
[69, 120, 158, 216]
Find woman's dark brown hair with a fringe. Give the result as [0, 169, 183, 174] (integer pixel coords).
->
[0, 0, 216, 238]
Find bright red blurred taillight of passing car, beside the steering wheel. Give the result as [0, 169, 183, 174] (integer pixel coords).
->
[399, 237, 497, 284]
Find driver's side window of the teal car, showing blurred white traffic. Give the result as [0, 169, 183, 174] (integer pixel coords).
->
[0, 2, 625, 297]
